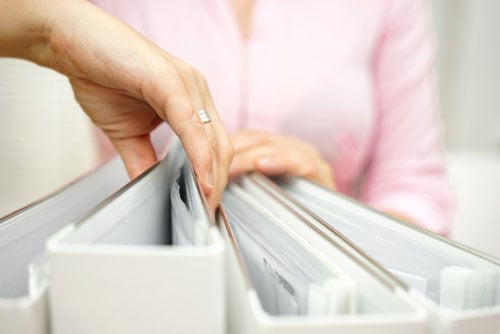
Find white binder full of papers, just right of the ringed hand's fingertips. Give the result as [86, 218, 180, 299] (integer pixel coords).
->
[221, 177, 427, 333]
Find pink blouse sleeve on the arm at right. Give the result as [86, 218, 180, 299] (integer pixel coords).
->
[362, 0, 454, 235]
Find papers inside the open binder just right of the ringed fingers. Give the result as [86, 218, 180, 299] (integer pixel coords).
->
[224, 185, 356, 315]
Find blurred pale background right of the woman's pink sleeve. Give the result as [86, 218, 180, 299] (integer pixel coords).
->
[432, 0, 500, 258]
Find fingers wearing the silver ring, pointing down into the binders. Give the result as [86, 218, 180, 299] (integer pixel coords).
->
[147, 61, 232, 211]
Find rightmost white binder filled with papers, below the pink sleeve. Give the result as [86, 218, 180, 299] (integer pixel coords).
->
[273, 178, 500, 333]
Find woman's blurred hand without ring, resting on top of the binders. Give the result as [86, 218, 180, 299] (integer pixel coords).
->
[229, 130, 335, 189]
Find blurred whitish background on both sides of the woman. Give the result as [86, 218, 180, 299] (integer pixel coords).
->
[0, 0, 500, 258]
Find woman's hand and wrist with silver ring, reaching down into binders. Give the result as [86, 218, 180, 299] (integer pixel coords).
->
[0, 0, 232, 208]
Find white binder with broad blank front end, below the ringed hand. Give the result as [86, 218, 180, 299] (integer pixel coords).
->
[47, 142, 225, 334]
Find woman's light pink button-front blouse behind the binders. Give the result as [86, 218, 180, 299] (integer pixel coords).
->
[94, 0, 454, 234]
